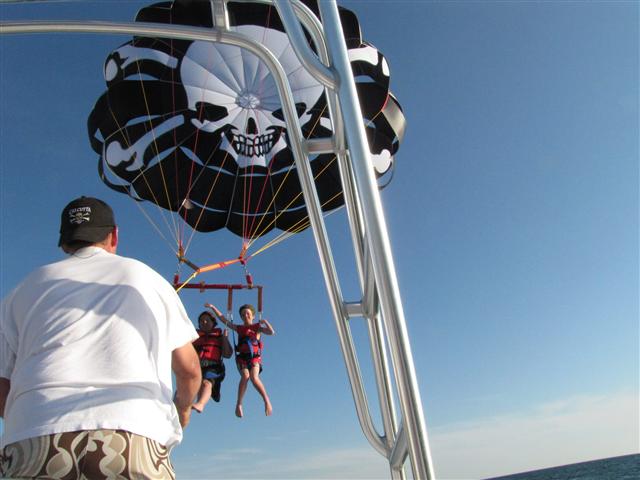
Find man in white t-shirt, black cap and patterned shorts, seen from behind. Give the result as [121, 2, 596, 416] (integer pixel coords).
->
[0, 197, 201, 479]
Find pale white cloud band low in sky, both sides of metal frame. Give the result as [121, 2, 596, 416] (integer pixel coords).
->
[176, 392, 640, 480]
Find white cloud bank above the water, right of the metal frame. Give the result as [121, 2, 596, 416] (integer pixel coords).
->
[430, 392, 640, 480]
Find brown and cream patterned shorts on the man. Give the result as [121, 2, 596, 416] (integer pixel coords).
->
[0, 430, 175, 480]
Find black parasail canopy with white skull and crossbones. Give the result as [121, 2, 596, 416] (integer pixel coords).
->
[88, 0, 405, 238]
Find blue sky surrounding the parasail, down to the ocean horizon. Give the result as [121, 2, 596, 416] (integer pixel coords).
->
[0, 0, 640, 479]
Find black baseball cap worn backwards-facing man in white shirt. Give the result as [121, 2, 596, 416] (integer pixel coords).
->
[58, 197, 116, 246]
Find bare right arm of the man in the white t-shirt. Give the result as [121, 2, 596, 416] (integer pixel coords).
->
[171, 343, 202, 428]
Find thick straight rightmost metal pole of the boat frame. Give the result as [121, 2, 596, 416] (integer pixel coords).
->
[318, 0, 433, 479]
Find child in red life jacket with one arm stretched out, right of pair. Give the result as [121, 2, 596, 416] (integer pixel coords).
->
[205, 303, 276, 417]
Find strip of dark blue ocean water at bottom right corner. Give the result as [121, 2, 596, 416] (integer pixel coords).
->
[487, 454, 640, 480]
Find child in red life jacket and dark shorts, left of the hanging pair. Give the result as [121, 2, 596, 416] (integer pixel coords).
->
[192, 311, 232, 412]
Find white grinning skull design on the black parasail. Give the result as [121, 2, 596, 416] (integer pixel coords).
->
[180, 25, 323, 168]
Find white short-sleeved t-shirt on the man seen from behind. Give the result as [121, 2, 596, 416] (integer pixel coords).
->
[0, 247, 198, 447]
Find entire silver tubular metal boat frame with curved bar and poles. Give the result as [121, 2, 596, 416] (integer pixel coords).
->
[0, 0, 434, 480]
